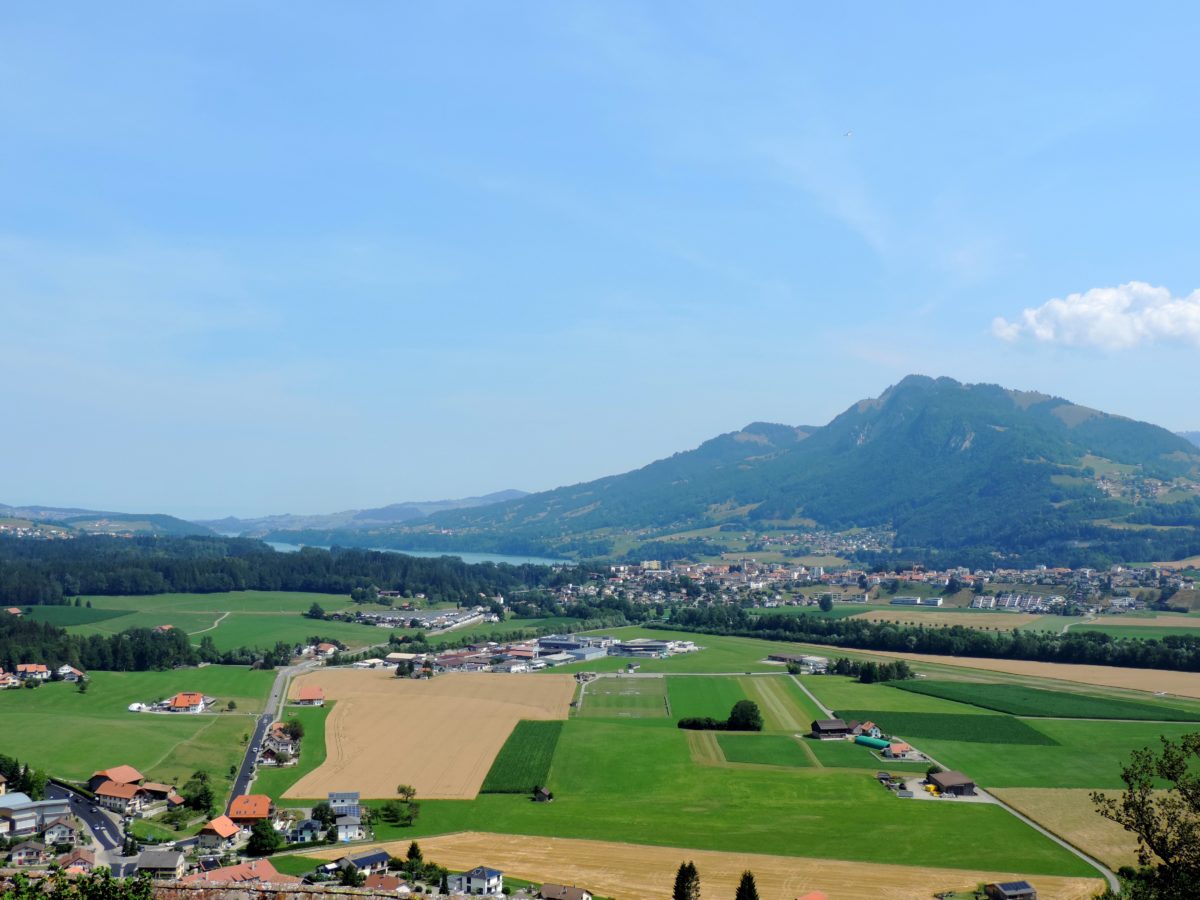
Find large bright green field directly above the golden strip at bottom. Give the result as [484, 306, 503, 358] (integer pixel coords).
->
[364, 719, 1092, 876]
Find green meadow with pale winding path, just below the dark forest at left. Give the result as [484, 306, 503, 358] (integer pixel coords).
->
[57, 590, 388, 650]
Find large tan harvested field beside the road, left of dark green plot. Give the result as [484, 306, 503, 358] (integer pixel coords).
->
[283, 668, 575, 800]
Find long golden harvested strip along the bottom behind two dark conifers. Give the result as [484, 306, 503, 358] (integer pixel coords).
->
[313, 832, 1104, 900]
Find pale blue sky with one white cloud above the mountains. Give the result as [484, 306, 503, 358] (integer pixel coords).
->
[0, 1, 1200, 516]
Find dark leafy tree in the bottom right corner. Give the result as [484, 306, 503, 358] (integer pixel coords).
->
[1092, 733, 1200, 900]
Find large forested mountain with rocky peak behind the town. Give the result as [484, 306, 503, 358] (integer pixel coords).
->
[290, 376, 1200, 562]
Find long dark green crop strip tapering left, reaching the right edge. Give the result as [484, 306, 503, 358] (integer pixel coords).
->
[889, 679, 1200, 722]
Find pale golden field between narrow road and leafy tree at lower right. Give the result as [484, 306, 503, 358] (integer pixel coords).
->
[991, 787, 1138, 870]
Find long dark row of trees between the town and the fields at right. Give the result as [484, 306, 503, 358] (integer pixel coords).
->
[667, 606, 1200, 672]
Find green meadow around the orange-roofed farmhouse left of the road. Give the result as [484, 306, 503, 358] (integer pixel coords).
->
[0, 666, 275, 784]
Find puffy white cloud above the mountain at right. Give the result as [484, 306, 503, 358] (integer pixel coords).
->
[991, 281, 1200, 350]
